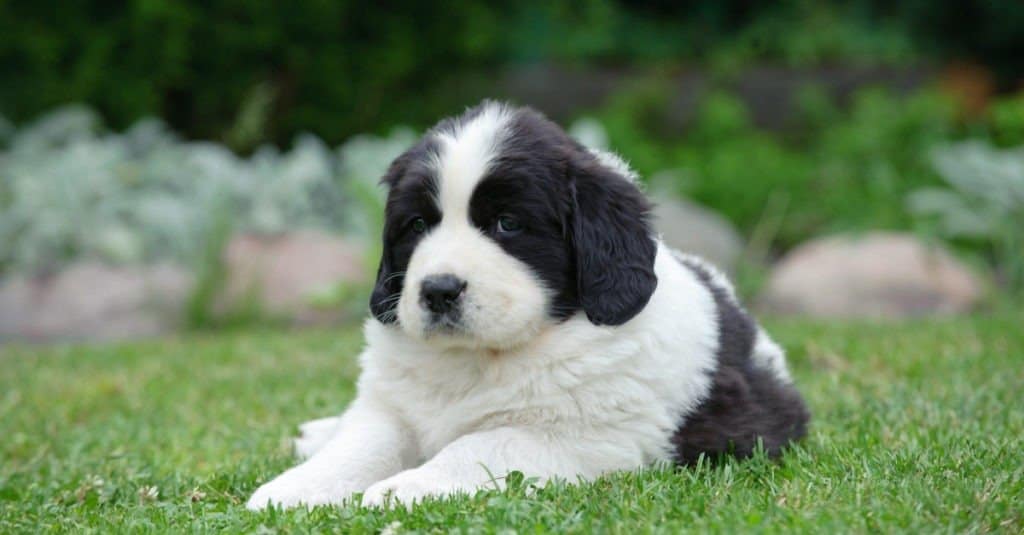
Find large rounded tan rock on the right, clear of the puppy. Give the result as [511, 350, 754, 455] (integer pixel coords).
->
[760, 233, 982, 318]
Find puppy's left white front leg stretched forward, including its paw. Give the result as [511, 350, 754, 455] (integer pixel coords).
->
[246, 399, 417, 510]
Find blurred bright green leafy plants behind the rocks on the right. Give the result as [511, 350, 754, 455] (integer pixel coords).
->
[596, 82, 956, 249]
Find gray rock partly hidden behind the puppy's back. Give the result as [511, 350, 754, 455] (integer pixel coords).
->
[651, 194, 743, 275]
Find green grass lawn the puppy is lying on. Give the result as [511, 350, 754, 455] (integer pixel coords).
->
[0, 315, 1024, 533]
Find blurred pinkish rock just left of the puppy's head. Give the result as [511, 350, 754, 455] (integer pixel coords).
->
[220, 231, 369, 324]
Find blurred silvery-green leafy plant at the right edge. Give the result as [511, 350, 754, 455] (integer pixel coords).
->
[907, 140, 1024, 295]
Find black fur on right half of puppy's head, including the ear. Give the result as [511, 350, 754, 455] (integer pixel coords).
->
[470, 109, 657, 325]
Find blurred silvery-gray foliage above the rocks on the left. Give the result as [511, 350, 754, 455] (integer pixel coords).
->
[0, 107, 415, 274]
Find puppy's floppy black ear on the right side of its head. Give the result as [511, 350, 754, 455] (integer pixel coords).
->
[568, 149, 657, 325]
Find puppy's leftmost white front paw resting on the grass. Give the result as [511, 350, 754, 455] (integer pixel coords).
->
[246, 466, 360, 510]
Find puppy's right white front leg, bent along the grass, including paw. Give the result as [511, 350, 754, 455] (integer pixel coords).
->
[362, 427, 626, 506]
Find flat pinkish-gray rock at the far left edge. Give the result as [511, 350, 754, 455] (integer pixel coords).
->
[0, 261, 193, 341]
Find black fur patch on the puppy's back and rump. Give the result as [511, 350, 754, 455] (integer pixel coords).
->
[672, 259, 810, 464]
